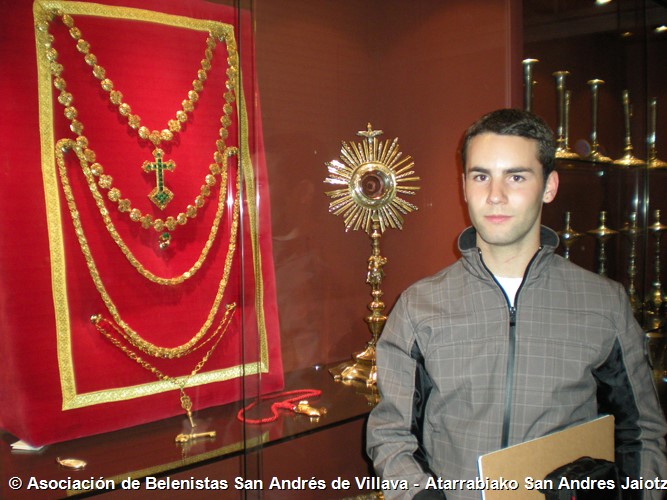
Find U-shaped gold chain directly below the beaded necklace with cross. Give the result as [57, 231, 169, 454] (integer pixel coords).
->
[55, 139, 238, 286]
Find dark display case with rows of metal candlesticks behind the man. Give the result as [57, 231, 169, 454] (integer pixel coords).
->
[524, 1, 667, 407]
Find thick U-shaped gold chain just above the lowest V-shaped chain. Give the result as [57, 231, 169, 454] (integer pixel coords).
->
[57, 140, 241, 359]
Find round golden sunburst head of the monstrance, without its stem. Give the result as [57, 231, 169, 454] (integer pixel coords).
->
[324, 123, 419, 234]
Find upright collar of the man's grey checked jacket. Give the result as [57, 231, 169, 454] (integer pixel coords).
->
[458, 226, 559, 281]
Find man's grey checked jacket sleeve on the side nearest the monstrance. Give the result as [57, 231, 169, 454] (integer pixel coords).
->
[366, 294, 445, 499]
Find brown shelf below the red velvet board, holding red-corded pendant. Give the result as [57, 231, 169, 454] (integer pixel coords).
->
[0, 365, 371, 498]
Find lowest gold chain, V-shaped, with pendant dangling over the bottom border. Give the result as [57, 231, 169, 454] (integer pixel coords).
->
[90, 303, 236, 428]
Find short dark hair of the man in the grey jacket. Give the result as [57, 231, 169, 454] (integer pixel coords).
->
[461, 108, 556, 182]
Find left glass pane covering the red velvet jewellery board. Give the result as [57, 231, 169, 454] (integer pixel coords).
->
[0, 1, 272, 496]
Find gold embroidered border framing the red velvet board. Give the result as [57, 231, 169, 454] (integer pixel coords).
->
[33, 0, 269, 410]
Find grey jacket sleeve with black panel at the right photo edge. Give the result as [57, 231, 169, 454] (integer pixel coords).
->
[594, 285, 667, 499]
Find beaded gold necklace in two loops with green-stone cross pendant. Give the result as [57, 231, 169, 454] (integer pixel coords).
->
[37, 11, 239, 248]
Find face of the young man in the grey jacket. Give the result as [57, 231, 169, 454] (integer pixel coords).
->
[463, 133, 558, 251]
